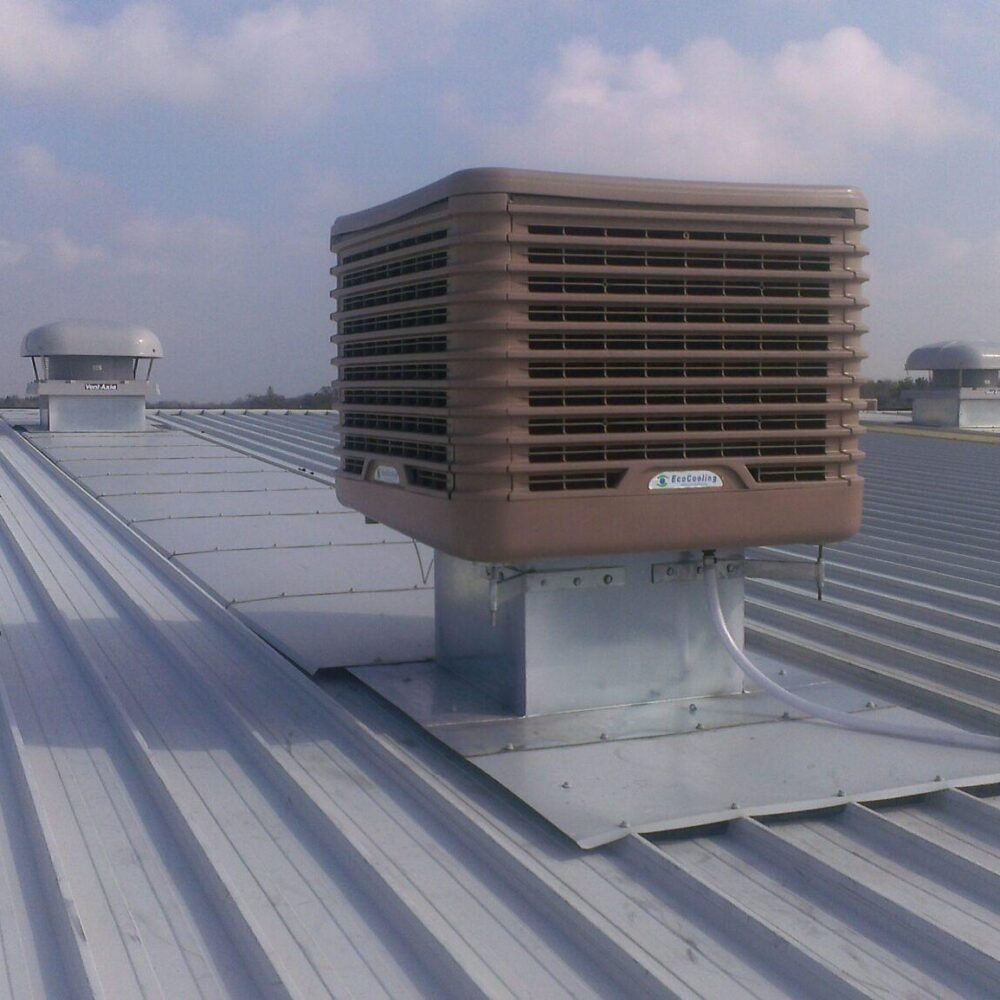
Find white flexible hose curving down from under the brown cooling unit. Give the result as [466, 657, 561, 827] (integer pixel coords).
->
[705, 557, 1000, 751]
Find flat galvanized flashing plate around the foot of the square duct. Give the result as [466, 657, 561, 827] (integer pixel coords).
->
[352, 648, 1000, 847]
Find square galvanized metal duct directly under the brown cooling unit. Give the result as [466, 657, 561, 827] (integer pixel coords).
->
[434, 552, 743, 716]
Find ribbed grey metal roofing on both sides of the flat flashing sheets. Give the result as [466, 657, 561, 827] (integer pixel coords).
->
[0, 408, 1000, 1000]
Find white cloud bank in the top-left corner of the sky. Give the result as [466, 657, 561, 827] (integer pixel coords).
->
[0, 0, 378, 118]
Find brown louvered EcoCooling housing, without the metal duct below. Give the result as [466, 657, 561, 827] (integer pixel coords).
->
[332, 171, 867, 558]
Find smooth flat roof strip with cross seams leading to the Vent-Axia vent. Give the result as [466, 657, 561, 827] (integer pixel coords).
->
[22, 414, 433, 672]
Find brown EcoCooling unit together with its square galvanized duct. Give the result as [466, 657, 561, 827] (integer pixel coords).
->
[332, 169, 867, 714]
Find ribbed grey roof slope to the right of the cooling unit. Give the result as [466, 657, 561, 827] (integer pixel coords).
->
[747, 433, 1000, 732]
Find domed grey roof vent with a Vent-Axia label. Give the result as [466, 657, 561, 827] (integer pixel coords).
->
[21, 320, 163, 431]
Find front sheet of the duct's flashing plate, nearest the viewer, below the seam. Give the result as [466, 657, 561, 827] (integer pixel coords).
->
[475, 708, 1000, 847]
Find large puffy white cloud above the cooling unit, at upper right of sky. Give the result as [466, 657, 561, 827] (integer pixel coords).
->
[484, 27, 983, 180]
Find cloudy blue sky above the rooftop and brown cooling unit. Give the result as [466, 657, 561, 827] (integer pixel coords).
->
[0, 0, 1000, 402]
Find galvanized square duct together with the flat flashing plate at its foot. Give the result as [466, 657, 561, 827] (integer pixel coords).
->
[346, 552, 1000, 847]
